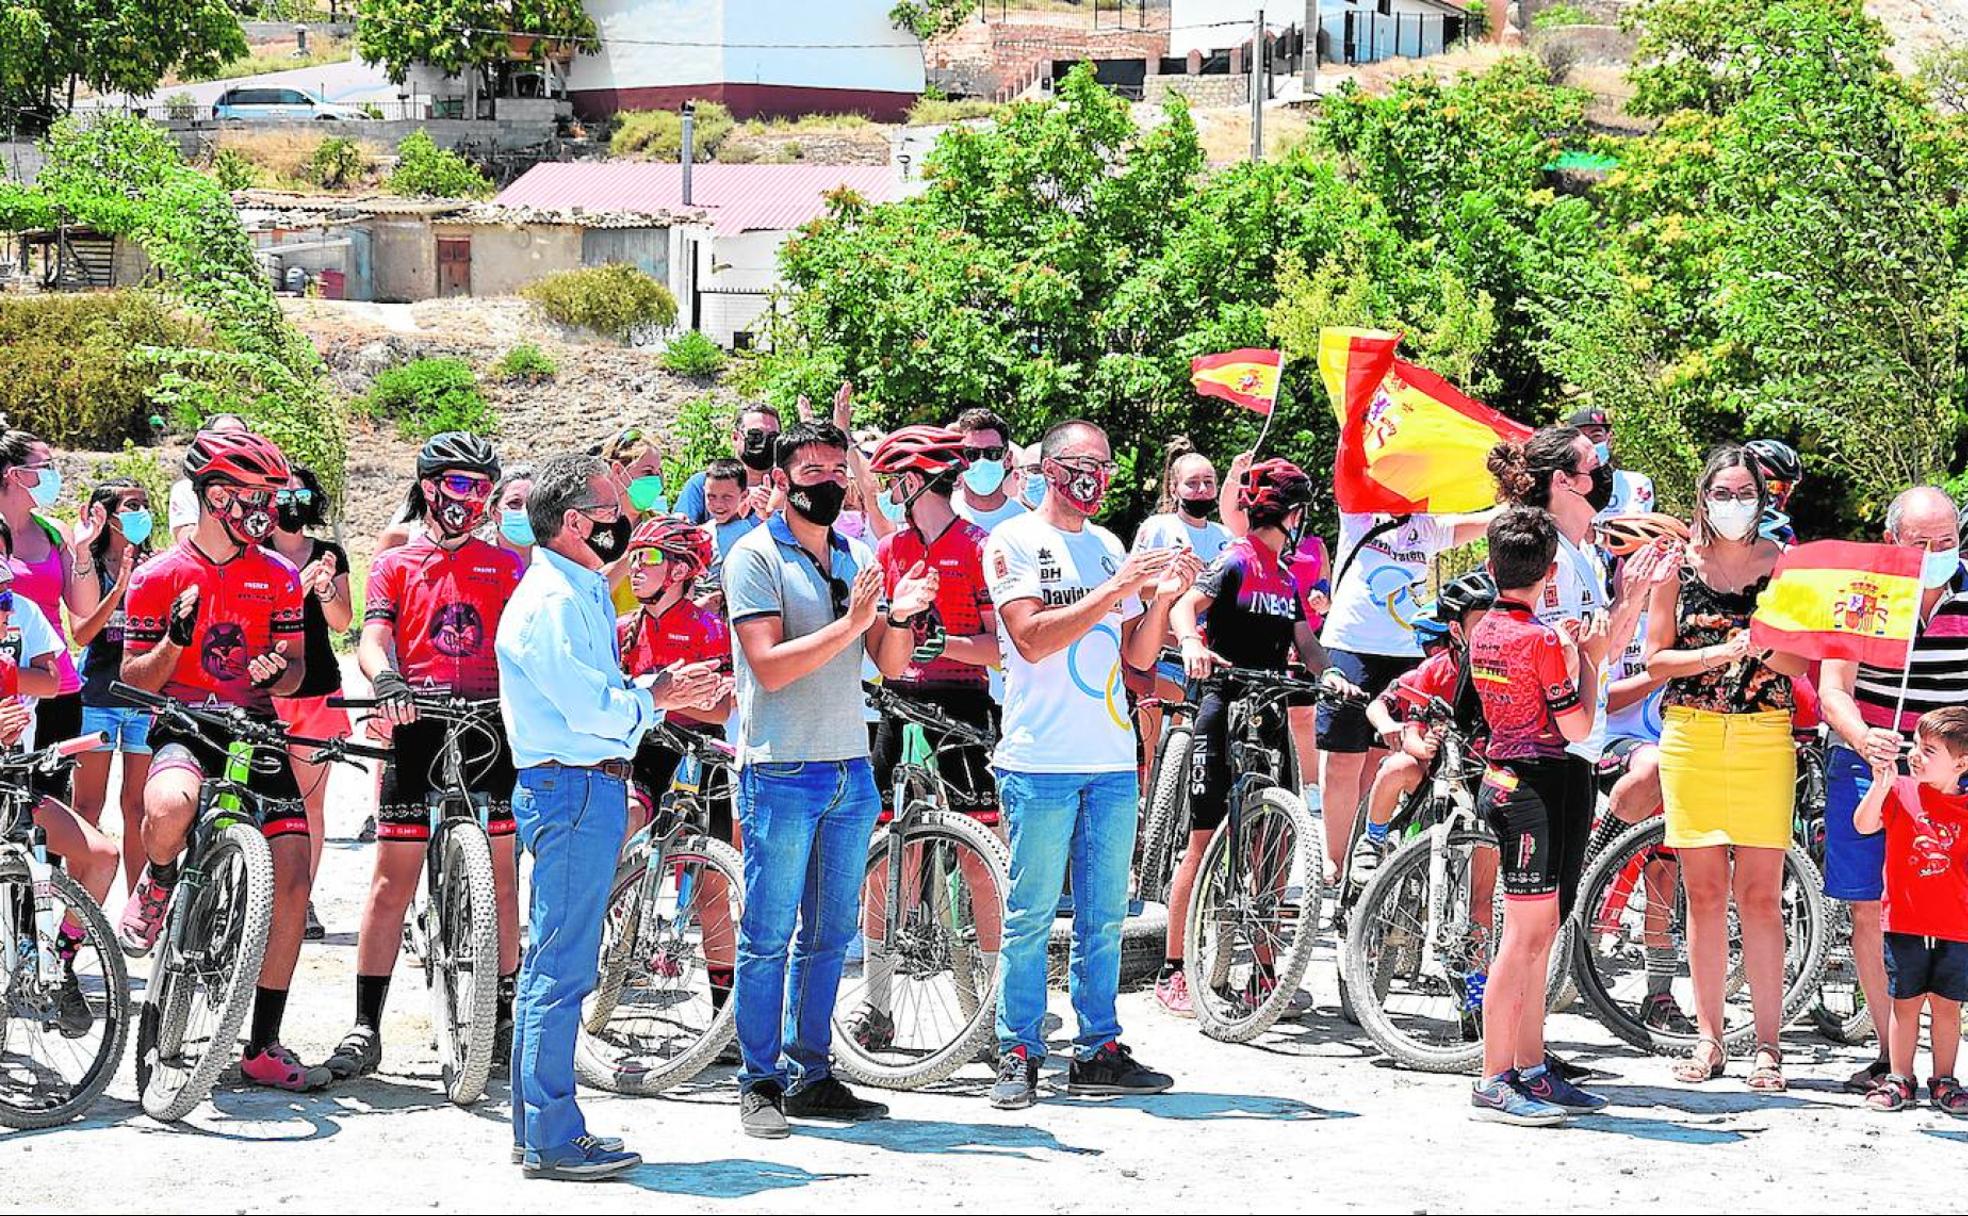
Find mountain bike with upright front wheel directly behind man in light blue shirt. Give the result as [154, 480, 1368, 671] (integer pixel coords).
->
[329, 689, 512, 1106]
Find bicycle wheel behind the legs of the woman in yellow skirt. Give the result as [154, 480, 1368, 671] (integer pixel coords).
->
[1574, 819, 1826, 1055]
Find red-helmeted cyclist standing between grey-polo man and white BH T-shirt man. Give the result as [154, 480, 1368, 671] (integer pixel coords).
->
[848, 427, 1002, 1051]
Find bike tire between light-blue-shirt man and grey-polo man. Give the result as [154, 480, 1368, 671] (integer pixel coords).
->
[575, 836, 744, 1098]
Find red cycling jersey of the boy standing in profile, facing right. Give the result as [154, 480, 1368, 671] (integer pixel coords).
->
[1470, 600, 1578, 760]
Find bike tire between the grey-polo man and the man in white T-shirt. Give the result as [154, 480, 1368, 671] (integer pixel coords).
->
[834, 811, 1012, 1090]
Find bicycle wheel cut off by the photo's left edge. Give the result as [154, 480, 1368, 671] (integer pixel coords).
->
[0, 856, 130, 1127]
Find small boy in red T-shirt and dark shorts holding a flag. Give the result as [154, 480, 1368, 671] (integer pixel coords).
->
[1852, 704, 1968, 1120]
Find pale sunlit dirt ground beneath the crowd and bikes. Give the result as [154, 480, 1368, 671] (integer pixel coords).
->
[0, 724, 1968, 1212]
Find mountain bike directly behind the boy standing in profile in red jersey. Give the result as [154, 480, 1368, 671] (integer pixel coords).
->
[1340, 699, 1570, 1072]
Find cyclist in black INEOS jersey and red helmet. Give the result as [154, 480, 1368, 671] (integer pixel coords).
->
[1155, 458, 1352, 1017]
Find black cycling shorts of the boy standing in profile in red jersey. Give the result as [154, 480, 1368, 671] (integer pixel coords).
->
[1476, 756, 1594, 917]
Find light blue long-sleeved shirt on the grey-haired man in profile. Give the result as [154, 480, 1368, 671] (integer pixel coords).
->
[496, 545, 659, 767]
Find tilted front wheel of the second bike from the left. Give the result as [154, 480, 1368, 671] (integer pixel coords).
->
[136, 822, 274, 1124]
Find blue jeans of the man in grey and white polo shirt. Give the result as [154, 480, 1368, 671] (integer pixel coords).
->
[732, 760, 882, 1092]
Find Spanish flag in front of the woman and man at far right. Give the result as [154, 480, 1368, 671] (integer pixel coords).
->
[1750, 541, 1921, 669]
